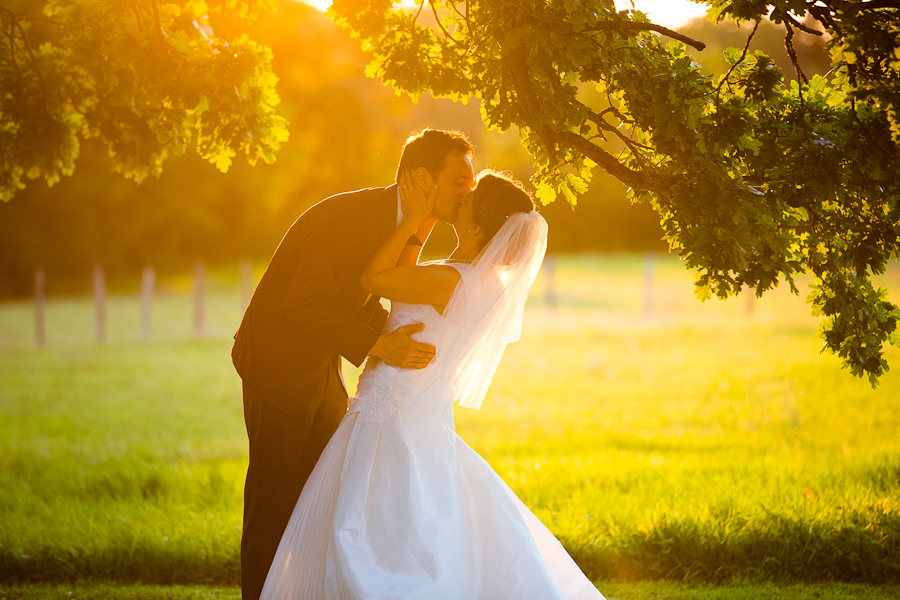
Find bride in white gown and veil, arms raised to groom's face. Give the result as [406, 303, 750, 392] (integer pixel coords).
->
[262, 169, 603, 600]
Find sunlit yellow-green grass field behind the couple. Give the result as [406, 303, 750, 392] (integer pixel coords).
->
[0, 255, 900, 599]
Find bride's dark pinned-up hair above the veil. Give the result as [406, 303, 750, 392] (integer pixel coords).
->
[472, 169, 536, 240]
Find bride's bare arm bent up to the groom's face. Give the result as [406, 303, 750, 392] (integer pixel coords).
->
[361, 169, 459, 306]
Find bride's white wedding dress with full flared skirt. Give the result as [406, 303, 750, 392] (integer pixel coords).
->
[262, 274, 603, 600]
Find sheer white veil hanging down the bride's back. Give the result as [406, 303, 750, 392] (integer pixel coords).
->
[407, 211, 547, 443]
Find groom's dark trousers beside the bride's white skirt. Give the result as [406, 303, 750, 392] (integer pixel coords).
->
[241, 373, 347, 600]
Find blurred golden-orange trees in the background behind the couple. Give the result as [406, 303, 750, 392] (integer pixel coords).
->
[0, 0, 829, 297]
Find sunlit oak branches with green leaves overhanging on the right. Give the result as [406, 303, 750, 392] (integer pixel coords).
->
[328, 0, 900, 385]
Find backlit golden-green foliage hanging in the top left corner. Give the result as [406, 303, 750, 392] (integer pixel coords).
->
[0, 0, 287, 200]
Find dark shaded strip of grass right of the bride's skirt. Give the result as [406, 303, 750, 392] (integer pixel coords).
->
[564, 506, 900, 585]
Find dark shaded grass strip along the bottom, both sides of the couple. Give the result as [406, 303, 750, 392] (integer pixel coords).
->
[0, 506, 900, 585]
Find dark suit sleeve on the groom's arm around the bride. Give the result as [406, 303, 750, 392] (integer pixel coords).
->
[285, 216, 381, 367]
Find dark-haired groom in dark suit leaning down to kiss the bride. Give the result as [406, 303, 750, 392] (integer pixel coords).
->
[231, 129, 474, 600]
